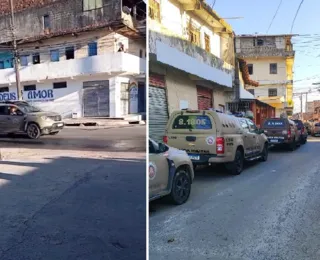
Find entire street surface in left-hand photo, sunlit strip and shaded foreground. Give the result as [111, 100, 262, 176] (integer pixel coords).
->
[0, 126, 146, 260]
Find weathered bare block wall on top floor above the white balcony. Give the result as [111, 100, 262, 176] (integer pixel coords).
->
[0, 0, 121, 43]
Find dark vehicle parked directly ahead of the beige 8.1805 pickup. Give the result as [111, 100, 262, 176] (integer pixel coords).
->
[262, 118, 301, 151]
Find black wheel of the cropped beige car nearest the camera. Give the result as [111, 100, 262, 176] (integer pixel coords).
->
[170, 168, 191, 205]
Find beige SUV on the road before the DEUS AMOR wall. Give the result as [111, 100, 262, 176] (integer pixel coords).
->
[0, 101, 64, 139]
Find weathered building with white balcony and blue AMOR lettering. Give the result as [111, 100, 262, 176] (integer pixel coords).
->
[0, 0, 146, 117]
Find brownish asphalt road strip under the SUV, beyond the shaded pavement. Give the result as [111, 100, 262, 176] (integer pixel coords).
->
[0, 125, 146, 152]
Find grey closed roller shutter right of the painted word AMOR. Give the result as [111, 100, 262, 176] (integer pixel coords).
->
[82, 81, 110, 117]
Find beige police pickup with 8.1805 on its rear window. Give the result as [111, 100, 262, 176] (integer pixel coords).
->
[164, 110, 268, 175]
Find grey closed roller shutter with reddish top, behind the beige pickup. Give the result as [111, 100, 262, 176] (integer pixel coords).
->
[149, 74, 169, 142]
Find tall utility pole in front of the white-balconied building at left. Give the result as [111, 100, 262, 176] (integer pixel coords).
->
[10, 0, 22, 100]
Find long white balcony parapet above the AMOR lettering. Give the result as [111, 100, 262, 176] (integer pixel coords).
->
[0, 52, 146, 84]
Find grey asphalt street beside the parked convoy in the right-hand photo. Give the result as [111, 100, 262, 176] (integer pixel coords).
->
[149, 138, 320, 260]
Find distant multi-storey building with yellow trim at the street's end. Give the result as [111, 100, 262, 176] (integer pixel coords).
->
[236, 35, 295, 116]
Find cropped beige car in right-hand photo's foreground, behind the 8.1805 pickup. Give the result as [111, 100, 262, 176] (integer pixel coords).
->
[149, 139, 194, 205]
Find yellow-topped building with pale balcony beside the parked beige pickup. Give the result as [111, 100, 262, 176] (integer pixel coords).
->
[148, 0, 235, 139]
